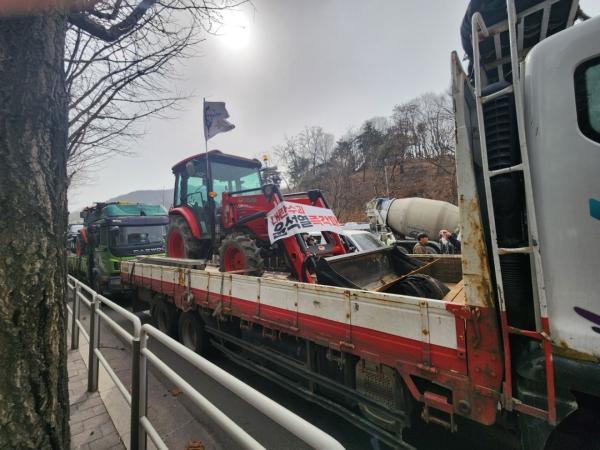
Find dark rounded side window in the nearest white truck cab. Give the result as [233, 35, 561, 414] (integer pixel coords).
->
[575, 57, 600, 143]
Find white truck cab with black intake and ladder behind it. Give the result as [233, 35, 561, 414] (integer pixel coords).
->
[452, 0, 600, 448]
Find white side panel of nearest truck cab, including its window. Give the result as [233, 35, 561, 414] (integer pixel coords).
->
[525, 17, 600, 358]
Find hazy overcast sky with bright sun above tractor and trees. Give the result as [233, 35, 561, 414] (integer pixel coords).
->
[69, 0, 600, 211]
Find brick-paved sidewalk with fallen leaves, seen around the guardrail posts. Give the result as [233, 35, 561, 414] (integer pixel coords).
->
[67, 307, 220, 450]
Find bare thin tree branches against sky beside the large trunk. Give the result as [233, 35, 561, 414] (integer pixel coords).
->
[65, 0, 246, 183]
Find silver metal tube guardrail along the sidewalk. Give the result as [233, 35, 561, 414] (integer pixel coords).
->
[67, 275, 344, 450]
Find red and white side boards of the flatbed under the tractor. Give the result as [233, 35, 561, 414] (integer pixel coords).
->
[121, 257, 467, 373]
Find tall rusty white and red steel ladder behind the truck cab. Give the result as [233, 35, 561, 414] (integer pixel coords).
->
[471, 0, 578, 425]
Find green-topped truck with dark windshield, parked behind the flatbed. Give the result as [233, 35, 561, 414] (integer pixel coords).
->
[67, 202, 169, 295]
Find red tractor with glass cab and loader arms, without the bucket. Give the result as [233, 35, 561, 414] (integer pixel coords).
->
[167, 150, 346, 282]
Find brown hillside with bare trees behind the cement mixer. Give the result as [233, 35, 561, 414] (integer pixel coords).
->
[275, 93, 456, 221]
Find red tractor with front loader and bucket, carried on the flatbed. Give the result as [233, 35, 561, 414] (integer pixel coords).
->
[167, 150, 447, 298]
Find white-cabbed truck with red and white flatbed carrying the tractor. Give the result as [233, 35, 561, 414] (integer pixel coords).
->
[121, 0, 600, 450]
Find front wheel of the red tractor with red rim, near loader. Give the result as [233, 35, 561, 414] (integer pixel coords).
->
[219, 233, 265, 277]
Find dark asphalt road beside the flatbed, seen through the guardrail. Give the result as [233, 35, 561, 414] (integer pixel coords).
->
[82, 296, 516, 450]
